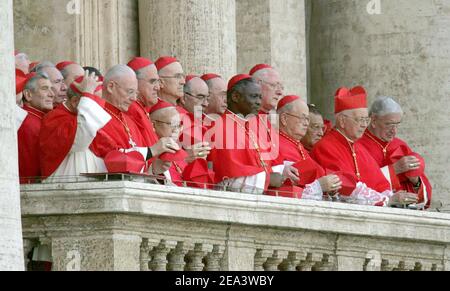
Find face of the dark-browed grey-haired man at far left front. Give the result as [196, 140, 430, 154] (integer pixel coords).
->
[25, 79, 55, 112]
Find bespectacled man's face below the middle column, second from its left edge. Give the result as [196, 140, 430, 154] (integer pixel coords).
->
[160, 63, 186, 105]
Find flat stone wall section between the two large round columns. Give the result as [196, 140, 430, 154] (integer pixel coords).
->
[236, 0, 308, 98]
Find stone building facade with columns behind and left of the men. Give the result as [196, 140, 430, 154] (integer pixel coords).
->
[0, 0, 450, 269]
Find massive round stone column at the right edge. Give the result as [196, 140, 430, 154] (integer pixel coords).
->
[310, 0, 450, 209]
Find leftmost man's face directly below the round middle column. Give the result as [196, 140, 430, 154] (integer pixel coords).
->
[138, 65, 161, 107]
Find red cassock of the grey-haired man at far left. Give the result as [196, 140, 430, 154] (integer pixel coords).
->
[17, 105, 45, 184]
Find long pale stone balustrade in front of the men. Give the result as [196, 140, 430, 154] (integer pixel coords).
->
[22, 181, 450, 271]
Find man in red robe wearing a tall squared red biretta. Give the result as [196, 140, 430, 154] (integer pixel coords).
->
[311, 87, 392, 204]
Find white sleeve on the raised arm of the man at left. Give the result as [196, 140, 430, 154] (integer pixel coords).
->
[70, 97, 111, 153]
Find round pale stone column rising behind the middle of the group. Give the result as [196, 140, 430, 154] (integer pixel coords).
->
[139, 0, 236, 78]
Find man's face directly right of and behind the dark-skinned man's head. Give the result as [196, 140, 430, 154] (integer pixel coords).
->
[260, 69, 284, 112]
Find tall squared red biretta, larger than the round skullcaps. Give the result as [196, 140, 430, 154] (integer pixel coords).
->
[335, 86, 367, 114]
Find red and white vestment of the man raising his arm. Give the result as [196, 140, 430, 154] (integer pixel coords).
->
[40, 93, 111, 179]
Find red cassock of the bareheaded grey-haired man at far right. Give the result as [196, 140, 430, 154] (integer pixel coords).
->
[358, 130, 433, 208]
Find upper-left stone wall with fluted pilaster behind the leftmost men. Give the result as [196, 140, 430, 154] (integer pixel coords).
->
[14, 0, 139, 71]
